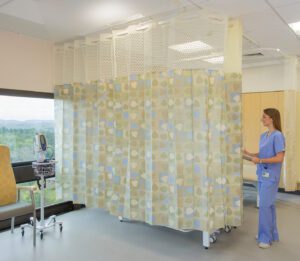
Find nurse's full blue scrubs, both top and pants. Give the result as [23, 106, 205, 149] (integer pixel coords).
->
[256, 130, 285, 244]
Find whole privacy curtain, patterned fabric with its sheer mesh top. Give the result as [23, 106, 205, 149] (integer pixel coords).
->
[55, 10, 242, 231]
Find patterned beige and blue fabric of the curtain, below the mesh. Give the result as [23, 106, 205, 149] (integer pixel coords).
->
[55, 70, 242, 231]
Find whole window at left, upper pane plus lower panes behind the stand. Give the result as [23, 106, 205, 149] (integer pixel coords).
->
[0, 89, 60, 206]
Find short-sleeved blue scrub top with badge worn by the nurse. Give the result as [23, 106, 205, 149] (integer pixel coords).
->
[256, 130, 285, 182]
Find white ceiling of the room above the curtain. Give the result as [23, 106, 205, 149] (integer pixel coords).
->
[0, 0, 300, 63]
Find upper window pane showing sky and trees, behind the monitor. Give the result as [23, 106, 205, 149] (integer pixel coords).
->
[0, 95, 54, 163]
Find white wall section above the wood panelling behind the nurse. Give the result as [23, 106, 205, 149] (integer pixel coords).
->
[242, 64, 285, 93]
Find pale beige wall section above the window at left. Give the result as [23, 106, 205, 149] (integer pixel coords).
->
[0, 30, 54, 92]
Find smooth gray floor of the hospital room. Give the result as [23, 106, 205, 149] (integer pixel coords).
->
[0, 188, 300, 261]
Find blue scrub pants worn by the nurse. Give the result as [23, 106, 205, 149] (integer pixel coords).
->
[258, 180, 279, 244]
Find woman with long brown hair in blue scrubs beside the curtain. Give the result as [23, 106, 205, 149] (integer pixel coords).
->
[244, 108, 285, 248]
